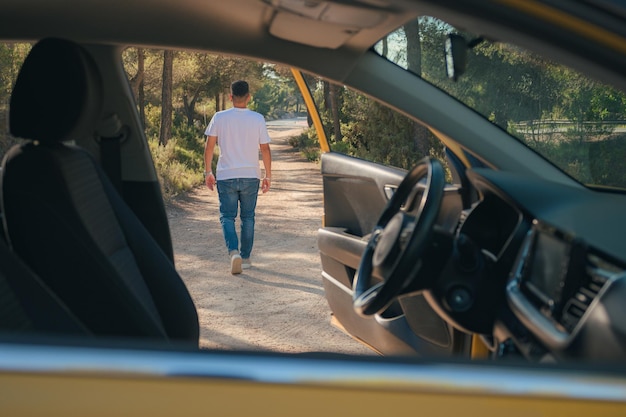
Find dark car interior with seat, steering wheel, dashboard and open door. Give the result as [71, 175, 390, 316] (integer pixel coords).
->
[0, 0, 626, 363]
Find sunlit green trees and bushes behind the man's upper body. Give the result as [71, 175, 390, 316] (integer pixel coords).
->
[122, 48, 298, 198]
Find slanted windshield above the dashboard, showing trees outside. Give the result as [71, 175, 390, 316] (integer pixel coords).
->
[374, 17, 626, 188]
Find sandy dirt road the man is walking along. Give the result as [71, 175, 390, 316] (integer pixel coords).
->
[163, 120, 374, 355]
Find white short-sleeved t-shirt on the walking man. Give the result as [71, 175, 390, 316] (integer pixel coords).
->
[204, 107, 270, 180]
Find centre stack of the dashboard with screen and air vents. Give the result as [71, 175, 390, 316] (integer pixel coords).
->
[504, 221, 626, 359]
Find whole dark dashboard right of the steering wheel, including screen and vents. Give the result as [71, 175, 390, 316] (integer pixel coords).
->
[429, 169, 626, 362]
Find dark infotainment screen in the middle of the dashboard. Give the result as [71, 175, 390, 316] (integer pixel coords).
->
[523, 230, 571, 308]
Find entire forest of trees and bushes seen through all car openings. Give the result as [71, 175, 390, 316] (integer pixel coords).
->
[0, 18, 626, 197]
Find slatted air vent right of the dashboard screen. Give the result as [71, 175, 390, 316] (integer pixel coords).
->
[560, 255, 620, 332]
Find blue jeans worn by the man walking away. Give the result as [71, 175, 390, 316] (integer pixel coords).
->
[217, 178, 259, 259]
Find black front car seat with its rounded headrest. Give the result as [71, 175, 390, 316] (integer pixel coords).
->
[0, 38, 199, 346]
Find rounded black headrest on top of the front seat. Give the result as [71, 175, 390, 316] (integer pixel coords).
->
[9, 38, 103, 143]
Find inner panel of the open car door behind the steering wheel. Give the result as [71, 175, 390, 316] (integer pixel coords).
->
[318, 152, 465, 355]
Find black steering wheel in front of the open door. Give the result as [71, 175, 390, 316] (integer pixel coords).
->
[352, 157, 445, 316]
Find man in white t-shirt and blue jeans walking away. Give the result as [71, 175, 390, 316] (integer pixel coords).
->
[204, 80, 272, 274]
